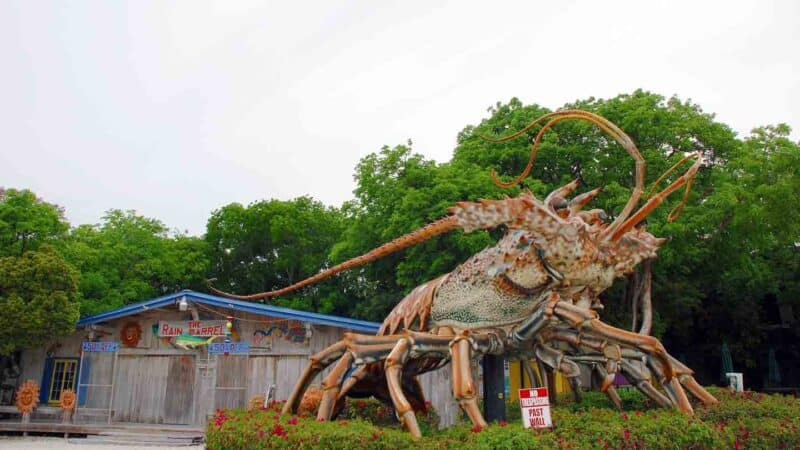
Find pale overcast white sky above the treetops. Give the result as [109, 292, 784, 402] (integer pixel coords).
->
[0, 0, 800, 235]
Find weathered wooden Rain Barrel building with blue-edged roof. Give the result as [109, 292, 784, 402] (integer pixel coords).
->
[0, 291, 457, 427]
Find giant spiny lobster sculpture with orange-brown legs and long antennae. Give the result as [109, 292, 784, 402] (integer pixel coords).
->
[212, 110, 716, 437]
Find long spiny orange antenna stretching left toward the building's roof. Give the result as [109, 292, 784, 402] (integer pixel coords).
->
[207, 216, 459, 300]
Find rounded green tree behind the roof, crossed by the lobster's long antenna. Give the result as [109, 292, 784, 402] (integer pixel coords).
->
[205, 197, 345, 313]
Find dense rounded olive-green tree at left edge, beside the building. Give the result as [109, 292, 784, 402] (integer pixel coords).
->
[0, 245, 79, 355]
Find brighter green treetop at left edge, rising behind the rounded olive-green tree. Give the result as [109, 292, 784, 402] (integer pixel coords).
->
[0, 187, 69, 256]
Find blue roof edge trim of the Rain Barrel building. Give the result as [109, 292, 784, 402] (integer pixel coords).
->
[77, 290, 381, 333]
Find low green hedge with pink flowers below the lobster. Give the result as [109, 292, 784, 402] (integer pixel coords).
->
[206, 388, 800, 450]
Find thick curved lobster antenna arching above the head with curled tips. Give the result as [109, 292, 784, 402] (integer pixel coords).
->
[481, 109, 645, 239]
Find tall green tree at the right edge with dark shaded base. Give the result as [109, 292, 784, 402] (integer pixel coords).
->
[690, 124, 800, 367]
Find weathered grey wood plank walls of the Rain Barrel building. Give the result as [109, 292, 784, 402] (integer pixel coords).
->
[20, 307, 457, 425]
